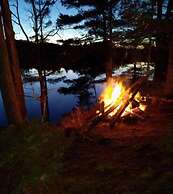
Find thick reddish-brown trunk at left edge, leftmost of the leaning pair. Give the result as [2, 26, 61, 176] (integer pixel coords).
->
[0, 18, 23, 124]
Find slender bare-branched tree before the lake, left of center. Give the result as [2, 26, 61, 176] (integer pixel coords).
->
[25, 0, 57, 121]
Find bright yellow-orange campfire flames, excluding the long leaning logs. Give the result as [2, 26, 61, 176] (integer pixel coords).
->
[96, 78, 147, 118]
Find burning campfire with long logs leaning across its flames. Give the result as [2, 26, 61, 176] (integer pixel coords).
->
[86, 75, 151, 131]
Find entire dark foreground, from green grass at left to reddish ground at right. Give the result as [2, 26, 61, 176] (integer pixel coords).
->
[0, 122, 173, 194]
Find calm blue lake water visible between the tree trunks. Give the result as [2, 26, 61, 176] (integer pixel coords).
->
[0, 64, 153, 126]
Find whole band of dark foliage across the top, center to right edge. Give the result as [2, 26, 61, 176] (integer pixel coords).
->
[57, 0, 173, 46]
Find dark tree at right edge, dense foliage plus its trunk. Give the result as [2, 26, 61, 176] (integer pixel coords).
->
[119, 0, 173, 81]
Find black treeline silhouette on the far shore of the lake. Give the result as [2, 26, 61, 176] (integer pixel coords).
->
[16, 40, 168, 69]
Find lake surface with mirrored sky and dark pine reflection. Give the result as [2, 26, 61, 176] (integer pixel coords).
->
[0, 64, 153, 126]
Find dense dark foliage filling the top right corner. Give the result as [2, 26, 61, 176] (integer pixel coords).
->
[120, 0, 173, 45]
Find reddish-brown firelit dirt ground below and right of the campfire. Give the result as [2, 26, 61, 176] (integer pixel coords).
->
[57, 98, 173, 194]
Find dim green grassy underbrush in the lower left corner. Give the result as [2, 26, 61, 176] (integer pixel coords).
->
[0, 122, 73, 194]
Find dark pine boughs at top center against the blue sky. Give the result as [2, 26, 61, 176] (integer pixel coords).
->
[57, 0, 121, 39]
